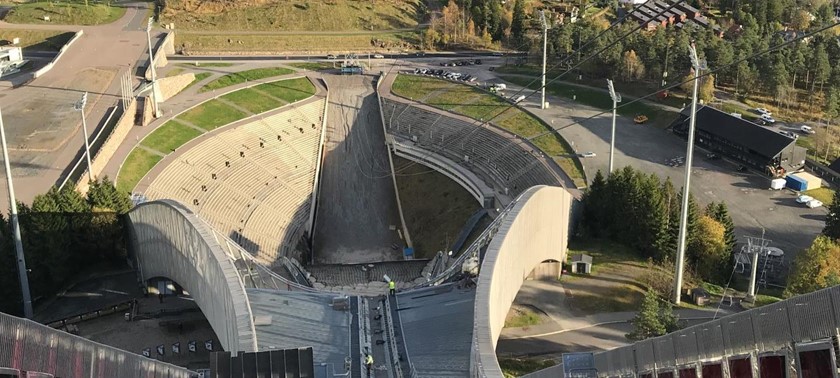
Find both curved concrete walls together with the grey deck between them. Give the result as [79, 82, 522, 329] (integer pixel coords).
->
[123, 186, 572, 377]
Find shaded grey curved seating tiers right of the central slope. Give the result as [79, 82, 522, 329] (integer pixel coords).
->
[381, 98, 563, 205]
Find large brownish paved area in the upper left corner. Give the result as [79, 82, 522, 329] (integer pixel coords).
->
[0, 2, 154, 209]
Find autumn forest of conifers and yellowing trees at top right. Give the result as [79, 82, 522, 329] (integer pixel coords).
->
[502, 0, 840, 120]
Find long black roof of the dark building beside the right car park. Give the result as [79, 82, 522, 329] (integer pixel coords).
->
[677, 105, 795, 157]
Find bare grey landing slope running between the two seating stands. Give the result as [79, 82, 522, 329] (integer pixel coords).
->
[314, 75, 403, 264]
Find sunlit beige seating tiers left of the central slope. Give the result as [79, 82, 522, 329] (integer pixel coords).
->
[137, 90, 327, 265]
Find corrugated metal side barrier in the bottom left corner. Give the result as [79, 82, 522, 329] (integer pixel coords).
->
[0, 313, 198, 378]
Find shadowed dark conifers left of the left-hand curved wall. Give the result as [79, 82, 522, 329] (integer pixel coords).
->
[0, 177, 132, 315]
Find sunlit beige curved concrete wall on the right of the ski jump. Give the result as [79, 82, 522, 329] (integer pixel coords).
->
[472, 186, 572, 378]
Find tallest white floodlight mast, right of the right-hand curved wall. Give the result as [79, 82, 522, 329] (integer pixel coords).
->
[674, 43, 706, 304]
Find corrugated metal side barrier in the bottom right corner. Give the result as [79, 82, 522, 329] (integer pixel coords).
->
[595, 286, 840, 378]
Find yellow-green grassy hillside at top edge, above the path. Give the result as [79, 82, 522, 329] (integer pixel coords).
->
[161, 0, 425, 31]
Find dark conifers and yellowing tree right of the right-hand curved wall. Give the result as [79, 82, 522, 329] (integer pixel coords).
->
[581, 166, 735, 284]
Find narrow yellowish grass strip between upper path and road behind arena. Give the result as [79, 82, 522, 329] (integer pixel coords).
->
[176, 31, 419, 54]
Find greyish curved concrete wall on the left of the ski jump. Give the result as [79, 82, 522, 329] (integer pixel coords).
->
[128, 200, 257, 354]
